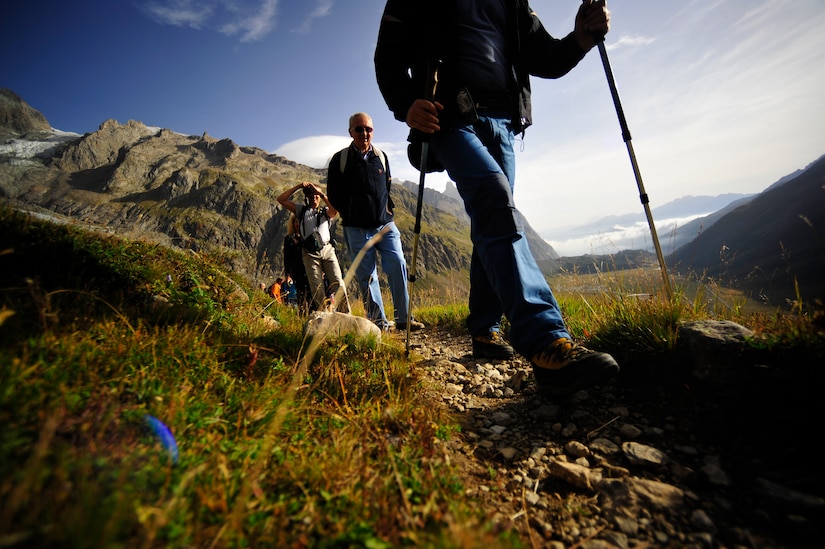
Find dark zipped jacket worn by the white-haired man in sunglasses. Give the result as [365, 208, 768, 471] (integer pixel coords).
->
[327, 145, 393, 229]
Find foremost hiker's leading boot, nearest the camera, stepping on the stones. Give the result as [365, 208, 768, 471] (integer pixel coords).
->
[531, 337, 619, 397]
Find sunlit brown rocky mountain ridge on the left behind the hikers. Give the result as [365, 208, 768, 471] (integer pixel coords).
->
[0, 90, 480, 281]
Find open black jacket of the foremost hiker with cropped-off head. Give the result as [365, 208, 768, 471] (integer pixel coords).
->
[376, 0, 586, 135]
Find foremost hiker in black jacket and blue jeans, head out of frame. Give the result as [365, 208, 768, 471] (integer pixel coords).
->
[375, 0, 619, 397]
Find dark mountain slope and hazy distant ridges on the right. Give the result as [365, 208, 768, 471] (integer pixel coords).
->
[556, 152, 825, 305]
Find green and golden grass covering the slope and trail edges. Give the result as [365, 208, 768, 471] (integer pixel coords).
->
[0, 203, 822, 547]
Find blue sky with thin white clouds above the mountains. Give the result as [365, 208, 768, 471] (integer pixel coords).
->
[0, 0, 825, 255]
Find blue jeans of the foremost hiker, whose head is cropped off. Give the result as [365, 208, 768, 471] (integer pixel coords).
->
[431, 113, 570, 359]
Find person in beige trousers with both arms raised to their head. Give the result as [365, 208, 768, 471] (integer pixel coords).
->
[276, 181, 349, 313]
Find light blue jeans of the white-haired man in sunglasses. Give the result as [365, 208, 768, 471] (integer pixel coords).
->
[344, 221, 410, 329]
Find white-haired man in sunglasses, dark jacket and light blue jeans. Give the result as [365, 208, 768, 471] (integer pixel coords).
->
[327, 112, 424, 331]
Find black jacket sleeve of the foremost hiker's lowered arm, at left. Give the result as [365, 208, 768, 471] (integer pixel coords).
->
[374, 0, 424, 122]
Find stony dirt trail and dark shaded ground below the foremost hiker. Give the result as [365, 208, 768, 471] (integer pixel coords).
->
[402, 328, 825, 548]
